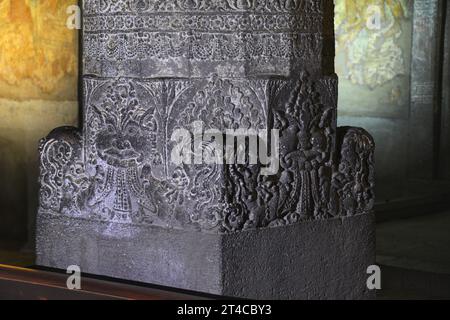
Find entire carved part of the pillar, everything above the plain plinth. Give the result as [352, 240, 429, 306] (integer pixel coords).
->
[39, 0, 374, 233]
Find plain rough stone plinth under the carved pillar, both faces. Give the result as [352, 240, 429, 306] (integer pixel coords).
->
[37, 214, 375, 299]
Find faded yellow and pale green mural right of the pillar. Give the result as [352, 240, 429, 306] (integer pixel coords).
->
[336, 0, 408, 88]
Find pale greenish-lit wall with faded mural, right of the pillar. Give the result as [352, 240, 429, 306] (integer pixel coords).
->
[335, 0, 449, 202]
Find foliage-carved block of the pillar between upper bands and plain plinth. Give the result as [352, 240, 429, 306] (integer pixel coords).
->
[40, 72, 374, 233]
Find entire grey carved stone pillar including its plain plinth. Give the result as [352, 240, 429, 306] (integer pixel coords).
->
[37, 0, 374, 298]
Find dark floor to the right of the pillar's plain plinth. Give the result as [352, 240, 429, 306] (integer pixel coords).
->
[377, 211, 450, 299]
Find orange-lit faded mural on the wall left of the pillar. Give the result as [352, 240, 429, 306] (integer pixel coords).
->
[0, 0, 77, 100]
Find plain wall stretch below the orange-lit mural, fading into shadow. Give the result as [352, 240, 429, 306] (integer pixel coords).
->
[0, 99, 78, 251]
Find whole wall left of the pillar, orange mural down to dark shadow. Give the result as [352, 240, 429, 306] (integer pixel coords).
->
[0, 0, 78, 243]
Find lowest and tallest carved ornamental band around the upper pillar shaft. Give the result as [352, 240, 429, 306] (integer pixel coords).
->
[84, 31, 322, 61]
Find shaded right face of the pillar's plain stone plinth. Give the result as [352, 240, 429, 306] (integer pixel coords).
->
[222, 213, 375, 299]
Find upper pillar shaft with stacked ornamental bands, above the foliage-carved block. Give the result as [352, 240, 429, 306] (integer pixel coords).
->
[83, 0, 324, 78]
